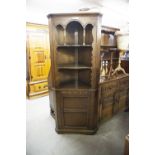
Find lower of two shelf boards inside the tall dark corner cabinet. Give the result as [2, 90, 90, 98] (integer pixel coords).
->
[58, 64, 91, 70]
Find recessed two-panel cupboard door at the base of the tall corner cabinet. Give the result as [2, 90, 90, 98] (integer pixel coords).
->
[62, 96, 88, 128]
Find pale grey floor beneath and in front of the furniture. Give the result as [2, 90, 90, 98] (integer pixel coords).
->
[26, 96, 129, 155]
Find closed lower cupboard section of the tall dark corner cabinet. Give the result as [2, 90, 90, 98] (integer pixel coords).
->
[52, 89, 98, 134]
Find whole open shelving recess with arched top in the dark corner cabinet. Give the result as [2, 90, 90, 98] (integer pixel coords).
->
[56, 21, 94, 88]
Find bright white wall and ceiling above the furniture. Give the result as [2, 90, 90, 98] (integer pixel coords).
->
[26, 0, 129, 30]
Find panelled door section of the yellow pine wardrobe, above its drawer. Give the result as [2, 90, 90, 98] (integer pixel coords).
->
[27, 24, 50, 81]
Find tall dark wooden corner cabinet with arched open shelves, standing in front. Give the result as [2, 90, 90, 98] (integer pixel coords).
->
[48, 12, 102, 134]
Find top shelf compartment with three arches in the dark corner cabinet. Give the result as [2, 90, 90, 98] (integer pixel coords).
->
[56, 21, 93, 47]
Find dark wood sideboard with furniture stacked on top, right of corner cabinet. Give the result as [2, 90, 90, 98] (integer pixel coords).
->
[98, 26, 129, 120]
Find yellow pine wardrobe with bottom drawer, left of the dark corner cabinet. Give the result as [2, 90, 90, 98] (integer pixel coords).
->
[26, 23, 50, 97]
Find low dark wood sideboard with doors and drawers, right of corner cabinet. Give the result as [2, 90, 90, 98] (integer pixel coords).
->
[99, 75, 129, 120]
